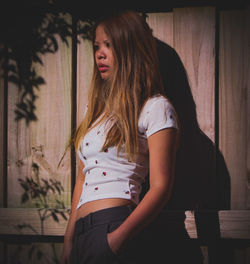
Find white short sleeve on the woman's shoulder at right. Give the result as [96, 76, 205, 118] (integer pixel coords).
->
[141, 96, 178, 138]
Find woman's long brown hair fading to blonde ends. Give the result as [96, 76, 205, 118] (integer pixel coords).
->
[74, 11, 163, 160]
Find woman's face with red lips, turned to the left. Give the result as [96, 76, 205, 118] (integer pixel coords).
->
[94, 25, 114, 80]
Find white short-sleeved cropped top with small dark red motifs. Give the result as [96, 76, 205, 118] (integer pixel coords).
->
[77, 95, 178, 209]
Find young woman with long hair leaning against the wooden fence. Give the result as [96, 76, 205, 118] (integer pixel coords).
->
[61, 11, 179, 264]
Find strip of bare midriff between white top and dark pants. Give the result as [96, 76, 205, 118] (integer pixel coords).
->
[76, 198, 135, 220]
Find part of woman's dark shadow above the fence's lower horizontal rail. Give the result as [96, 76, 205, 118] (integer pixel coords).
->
[157, 39, 230, 210]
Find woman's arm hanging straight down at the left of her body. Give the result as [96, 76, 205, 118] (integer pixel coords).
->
[61, 161, 85, 264]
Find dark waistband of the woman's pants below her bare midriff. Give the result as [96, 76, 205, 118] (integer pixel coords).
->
[75, 205, 135, 233]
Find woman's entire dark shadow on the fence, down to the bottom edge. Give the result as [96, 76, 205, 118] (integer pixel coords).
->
[138, 39, 230, 264]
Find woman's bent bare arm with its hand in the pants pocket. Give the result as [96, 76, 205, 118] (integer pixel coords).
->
[108, 128, 178, 253]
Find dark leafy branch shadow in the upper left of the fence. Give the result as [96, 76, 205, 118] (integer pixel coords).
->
[0, 0, 93, 125]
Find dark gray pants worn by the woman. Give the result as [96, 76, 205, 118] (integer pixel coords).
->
[70, 206, 137, 264]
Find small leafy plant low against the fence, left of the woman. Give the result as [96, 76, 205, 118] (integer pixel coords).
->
[16, 163, 69, 264]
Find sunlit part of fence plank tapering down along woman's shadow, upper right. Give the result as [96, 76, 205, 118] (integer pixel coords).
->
[174, 7, 215, 141]
